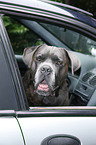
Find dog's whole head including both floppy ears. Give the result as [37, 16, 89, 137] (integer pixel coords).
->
[23, 45, 79, 96]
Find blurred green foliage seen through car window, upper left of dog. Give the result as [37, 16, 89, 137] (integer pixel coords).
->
[3, 16, 41, 54]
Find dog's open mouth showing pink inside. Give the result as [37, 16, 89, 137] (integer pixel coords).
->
[37, 80, 50, 92]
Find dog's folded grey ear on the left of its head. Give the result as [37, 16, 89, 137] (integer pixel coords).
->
[23, 45, 42, 68]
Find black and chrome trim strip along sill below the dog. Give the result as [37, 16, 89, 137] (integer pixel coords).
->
[16, 106, 96, 118]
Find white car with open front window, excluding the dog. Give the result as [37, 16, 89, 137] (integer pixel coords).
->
[0, 0, 96, 145]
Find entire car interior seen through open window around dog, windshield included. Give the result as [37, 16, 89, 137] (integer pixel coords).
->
[3, 17, 96, 106]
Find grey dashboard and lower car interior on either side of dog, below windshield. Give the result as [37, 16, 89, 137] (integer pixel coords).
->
[16, 52, 96, 106]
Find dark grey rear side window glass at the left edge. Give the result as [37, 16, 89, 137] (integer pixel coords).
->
[0, 35, 18, 110]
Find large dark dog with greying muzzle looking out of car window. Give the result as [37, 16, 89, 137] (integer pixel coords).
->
[23, 44, 80, 106]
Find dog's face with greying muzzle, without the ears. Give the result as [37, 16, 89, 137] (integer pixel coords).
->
[31, 47, 68, 96]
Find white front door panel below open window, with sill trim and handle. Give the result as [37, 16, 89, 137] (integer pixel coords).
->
[1, 16, 96, 145]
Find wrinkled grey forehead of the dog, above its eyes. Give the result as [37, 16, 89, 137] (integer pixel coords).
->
[37, 46, 65, 58]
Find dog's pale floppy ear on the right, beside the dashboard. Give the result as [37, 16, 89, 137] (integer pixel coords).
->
[64, 48, 81, 75]
